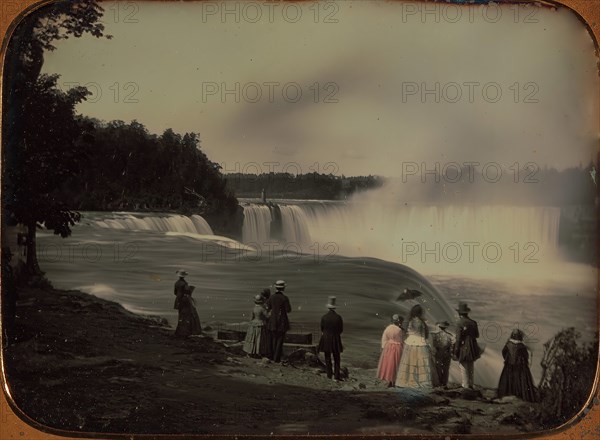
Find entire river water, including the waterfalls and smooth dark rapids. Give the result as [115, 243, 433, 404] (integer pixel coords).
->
[38, 200, 598, 387]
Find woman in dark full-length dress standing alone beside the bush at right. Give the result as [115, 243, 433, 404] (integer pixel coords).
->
[498, 329, 536, 402]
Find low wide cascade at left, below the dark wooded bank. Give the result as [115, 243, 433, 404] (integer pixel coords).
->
[94, 214, 213, 235]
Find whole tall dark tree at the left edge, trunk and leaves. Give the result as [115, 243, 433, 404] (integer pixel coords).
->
[2, 0, 110, 273]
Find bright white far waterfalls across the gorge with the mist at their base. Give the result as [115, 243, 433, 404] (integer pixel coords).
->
[238, 199, 560, 276]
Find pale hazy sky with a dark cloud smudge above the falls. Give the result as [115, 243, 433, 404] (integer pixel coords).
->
[38, 1, 599, 177]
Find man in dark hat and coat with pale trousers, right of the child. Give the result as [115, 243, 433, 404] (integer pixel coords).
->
[454, 303, 481, 388]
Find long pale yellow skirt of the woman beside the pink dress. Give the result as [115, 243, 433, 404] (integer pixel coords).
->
[396, 344, 432, 388]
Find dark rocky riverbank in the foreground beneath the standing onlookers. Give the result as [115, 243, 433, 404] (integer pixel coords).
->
[4, 288, 543, 435]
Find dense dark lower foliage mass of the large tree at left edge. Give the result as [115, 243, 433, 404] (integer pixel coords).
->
[5, 75, 92, 229]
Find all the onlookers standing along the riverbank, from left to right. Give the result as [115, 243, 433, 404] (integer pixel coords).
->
[174, 270, 536, 401]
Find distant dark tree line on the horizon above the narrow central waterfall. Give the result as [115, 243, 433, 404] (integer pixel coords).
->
[226, 172, 385, 200]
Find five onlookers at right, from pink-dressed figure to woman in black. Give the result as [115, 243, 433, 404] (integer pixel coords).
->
[377, 303, 536, 401]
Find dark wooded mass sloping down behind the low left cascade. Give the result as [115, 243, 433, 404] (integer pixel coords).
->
[62, 118, 239, 232]
